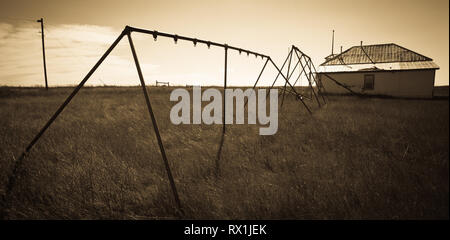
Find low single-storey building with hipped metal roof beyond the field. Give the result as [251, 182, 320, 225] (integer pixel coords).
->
[317, 43, 439, 98]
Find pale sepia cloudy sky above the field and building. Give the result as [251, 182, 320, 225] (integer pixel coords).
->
[0, 0, 449, 86]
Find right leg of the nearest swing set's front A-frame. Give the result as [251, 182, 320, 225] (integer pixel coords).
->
[127, 32, 183, 213]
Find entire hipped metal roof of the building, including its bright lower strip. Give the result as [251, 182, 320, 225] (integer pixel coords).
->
[319, 43, 439, 72]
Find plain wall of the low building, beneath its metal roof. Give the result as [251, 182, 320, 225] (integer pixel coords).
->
[318, 70, 435, 98]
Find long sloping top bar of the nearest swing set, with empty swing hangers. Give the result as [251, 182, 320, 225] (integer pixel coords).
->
[124, 26, 270, 59]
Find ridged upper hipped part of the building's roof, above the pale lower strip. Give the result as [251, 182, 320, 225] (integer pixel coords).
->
[321, 43, 433, 66]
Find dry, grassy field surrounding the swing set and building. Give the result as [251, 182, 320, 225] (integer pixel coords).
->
[0, 87, 449, 219]
